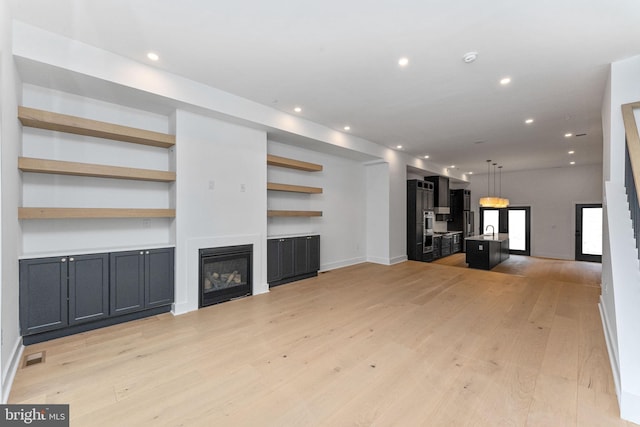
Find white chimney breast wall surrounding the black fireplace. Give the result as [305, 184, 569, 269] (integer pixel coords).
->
[174, 110, 268, 314]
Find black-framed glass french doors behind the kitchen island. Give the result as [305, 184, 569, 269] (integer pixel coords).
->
[480, 206, 531, 256]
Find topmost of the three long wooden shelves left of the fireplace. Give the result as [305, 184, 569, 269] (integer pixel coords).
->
[18, 107, 176, 148]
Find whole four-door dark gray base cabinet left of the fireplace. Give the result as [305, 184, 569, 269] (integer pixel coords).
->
[19, 248, 174, 345]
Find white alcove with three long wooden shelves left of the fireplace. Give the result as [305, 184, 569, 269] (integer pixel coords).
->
[17, 84, 176, 259]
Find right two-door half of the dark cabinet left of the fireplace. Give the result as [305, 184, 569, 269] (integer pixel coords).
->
[109, 248, 174, 316]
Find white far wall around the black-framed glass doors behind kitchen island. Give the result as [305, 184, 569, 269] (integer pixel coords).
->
[468, 165, 602, 259]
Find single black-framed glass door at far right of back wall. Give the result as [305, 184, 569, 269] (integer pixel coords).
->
[576, 203, 602, 262]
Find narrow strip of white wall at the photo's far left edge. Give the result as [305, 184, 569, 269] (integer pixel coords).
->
[0, 6, 22, 403]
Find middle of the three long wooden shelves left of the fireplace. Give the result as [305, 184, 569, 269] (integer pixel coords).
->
[18, 157, 176, 182]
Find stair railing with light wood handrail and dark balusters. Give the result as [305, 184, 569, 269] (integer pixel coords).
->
[622, 102, 640, 259]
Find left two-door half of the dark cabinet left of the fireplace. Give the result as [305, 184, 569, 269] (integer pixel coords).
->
[20, 254, 109, 335]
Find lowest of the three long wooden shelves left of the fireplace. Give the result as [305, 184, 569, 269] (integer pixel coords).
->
[18, 208, 176, 219]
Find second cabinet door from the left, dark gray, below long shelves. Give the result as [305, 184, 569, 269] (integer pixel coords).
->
[67, 254, 109, 325]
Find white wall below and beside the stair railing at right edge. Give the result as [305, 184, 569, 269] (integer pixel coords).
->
[600, 56, 640, 423]
